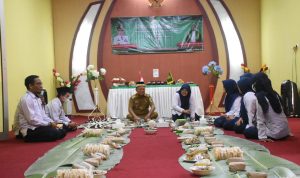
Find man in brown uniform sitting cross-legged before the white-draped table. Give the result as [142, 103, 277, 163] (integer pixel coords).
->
[127, 83, 158, 122]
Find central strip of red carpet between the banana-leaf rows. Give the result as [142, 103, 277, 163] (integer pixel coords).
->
[107, 128, 194, 178]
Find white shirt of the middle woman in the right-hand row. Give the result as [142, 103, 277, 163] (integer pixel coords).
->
[243, 92, 257, 128]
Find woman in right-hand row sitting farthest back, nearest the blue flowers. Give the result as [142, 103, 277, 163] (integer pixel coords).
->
[214, 79, 241, 130]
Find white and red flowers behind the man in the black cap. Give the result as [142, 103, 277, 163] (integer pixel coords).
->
[52, 69, 82, 93]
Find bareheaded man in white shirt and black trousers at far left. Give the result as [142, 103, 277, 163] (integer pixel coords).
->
[13, 75, 66, 142]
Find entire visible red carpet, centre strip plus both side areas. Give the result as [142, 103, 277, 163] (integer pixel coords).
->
[0, 117, 300, 178]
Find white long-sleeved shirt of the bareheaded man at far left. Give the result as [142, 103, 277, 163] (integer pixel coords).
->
[13, 91, 52, 137]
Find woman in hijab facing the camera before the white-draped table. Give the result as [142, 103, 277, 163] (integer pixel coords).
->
[172, 83, 199, 121]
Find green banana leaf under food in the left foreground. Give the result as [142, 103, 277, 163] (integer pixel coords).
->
[24, 135, 130, 178]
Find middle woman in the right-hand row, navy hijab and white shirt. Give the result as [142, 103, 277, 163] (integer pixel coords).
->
[233, 77, 256, 133]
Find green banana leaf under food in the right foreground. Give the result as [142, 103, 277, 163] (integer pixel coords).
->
[178, 135, 300, 178]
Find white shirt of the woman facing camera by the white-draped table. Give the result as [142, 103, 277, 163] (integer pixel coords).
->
[172, 93, 196, 118]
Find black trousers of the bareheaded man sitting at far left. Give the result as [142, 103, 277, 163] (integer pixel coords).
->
[24, 126, 66, 142]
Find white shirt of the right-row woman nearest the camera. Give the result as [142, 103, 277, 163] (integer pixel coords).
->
[256, 96, 290, 139]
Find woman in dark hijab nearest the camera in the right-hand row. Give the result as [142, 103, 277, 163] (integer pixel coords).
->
[244, 73, 290, 142]
